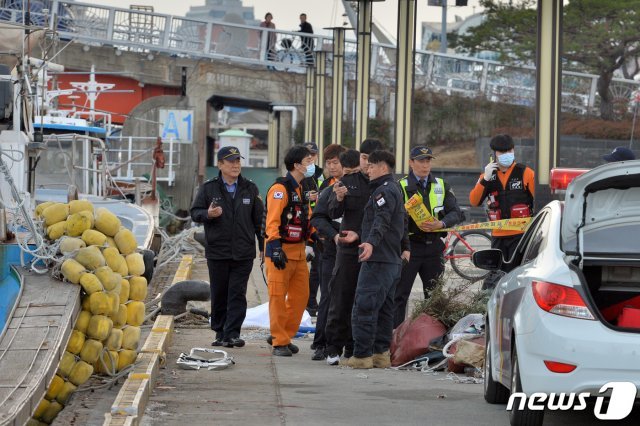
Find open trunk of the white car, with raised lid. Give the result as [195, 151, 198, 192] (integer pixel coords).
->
[561, 161, 640, 332]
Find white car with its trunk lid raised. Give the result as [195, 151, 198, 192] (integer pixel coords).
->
[473, 161, 640, 425]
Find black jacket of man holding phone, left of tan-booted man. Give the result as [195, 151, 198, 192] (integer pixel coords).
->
[327, 172, 371, 251]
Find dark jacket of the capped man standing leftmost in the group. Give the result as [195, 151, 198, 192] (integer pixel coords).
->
[191, 174, 264, 260]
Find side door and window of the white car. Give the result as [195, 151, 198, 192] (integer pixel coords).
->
[494, 209, 550, 383]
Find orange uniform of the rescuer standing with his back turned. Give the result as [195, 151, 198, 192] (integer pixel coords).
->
[265, 175, 311, 346]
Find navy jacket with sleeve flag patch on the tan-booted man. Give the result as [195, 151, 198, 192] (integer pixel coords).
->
[360, 174, 407, 263]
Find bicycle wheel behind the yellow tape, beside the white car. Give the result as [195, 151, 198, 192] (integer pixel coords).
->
[449, 231, 491, 281]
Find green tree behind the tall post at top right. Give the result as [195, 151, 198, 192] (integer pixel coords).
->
[456, 0, 640, 120]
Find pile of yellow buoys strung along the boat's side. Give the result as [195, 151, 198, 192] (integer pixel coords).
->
[32, 200, 147, 424]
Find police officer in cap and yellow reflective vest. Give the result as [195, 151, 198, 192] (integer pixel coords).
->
[393, 146, 462, 328]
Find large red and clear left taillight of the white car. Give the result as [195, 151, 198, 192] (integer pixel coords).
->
[531, 281, 595, 320]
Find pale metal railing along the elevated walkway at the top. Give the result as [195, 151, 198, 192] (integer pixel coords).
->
[0, 0, 640, 114]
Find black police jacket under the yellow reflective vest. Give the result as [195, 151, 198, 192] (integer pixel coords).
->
[401, 173, 462, 253]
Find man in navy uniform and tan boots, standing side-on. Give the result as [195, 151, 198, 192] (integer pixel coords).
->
[347, 151, 407, 369]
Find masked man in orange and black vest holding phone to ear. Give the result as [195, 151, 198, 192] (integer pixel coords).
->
[469, 135, 535, 288]
